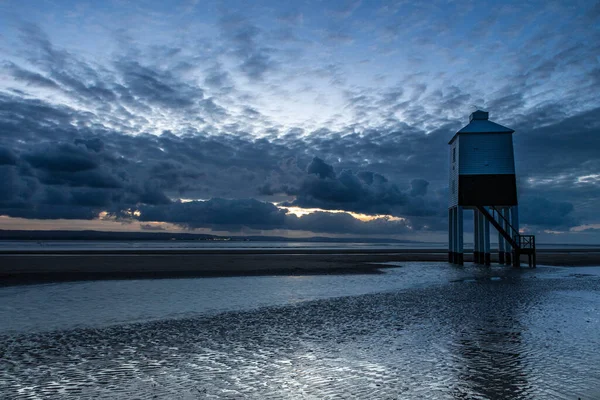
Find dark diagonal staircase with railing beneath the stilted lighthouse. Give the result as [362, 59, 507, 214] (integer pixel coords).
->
[477, 206, 536, 268]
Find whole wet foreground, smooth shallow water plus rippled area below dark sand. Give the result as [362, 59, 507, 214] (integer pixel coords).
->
[0, 263, 600, 399]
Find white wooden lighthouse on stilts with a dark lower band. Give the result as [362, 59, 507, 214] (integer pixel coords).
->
[448, 110, 536, 267]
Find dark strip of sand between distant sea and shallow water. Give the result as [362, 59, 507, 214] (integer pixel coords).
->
[0, 248, 600, 285]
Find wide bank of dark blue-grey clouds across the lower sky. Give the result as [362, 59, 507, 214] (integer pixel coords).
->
[0, 77, 598, 234]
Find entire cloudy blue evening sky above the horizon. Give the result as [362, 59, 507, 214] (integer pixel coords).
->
[0, 0, 600, 244]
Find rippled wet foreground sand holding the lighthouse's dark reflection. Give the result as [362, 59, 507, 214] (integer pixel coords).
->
[0, 266, 600, 399]
